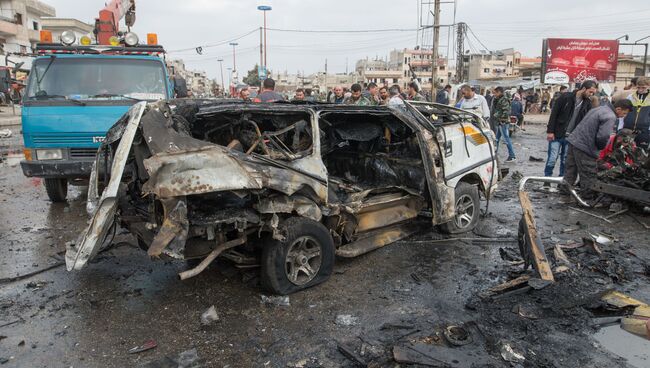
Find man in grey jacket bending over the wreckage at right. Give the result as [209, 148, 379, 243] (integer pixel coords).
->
[564, 100, 634, 197]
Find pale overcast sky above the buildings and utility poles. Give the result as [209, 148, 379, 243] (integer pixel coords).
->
[44, 0, 650, 78]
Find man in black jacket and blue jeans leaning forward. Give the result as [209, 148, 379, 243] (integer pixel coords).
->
[544, 80, 598, 180]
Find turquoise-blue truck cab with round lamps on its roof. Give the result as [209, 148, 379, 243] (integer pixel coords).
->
[21, 38, 173, 202]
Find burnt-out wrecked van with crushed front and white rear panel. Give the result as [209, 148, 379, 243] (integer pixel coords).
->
[66, 100, 500, 294]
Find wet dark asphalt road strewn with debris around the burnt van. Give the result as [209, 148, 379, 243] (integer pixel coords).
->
[0, 116, 650, 367]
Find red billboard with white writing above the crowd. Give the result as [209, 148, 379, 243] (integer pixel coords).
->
[542, 38, 618, 84]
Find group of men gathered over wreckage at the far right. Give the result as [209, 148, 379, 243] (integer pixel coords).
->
[544, 77, 650, 198]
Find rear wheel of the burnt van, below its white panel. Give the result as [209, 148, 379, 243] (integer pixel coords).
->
[442, 182, 481, 234]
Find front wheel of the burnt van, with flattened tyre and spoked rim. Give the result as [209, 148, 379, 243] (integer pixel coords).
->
[261, 217, 335, 295]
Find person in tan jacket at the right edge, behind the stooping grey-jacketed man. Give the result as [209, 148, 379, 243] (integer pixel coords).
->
[622, 77, 650, 150]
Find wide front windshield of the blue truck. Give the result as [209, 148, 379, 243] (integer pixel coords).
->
[26, 56, 167, 101]
